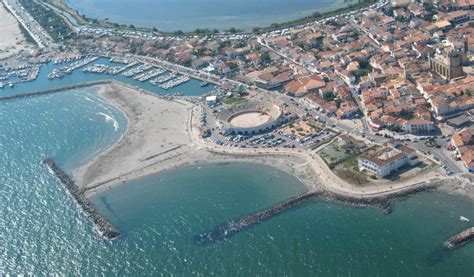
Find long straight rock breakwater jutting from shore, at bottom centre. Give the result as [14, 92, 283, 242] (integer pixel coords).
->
[193, 192, 317, 245]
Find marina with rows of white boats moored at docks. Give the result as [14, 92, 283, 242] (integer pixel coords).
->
[0, 56, 215, 98]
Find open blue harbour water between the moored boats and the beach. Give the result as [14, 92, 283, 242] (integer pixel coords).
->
[0, 58, 214, 96]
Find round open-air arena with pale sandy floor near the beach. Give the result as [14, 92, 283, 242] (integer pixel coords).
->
[217, 102, 284, 135]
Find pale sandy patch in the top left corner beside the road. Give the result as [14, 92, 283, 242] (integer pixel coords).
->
[0, 4, 30, 60]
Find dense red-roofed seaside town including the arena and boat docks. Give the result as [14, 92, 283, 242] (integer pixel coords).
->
[0, 0, 474, 190]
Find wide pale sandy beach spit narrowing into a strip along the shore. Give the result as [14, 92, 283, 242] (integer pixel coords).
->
[74, 83, 474, 201]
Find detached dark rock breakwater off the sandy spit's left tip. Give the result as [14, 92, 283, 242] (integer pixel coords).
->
[43, 159, 120, 240]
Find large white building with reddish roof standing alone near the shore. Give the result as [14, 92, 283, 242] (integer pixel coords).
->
[357, 141, 418, 177]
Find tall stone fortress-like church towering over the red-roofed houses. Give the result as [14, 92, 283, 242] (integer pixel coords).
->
[428, 49, 464, 80]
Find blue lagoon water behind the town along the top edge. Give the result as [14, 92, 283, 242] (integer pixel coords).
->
[65, 0, 346, 31]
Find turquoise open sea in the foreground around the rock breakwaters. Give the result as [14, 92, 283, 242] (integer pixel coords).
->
[0, 88, 474, 276]
